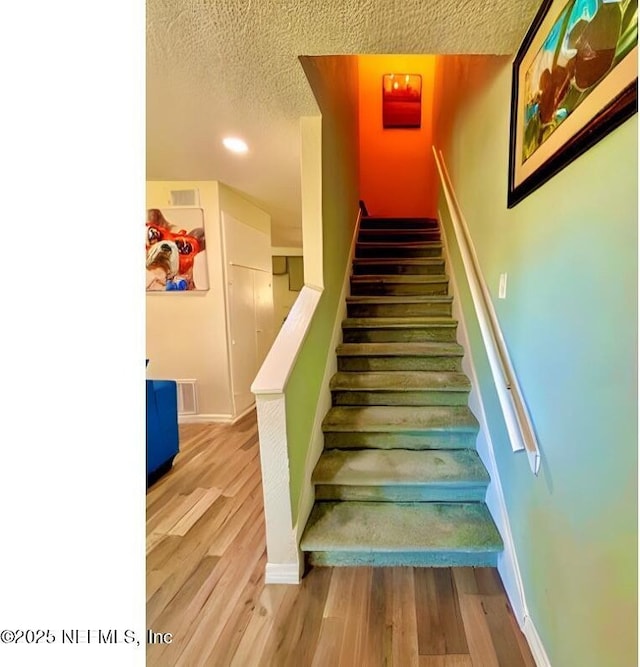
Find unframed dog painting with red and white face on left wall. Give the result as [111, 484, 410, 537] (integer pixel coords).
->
[145, 207, 209, 292]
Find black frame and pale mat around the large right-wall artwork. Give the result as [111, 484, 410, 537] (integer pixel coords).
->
[507, 0, 638, 208]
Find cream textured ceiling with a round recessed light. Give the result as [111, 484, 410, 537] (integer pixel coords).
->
[147, 0, 540, 245]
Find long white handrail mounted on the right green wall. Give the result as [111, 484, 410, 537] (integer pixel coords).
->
[433, 146, 540, 475]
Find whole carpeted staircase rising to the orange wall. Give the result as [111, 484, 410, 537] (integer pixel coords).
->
[301, 217, 502, 567]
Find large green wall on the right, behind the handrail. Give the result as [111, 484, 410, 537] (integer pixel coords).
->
[435, 56, 638, 667]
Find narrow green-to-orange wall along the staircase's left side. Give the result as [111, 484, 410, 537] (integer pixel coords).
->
[285, 56, 359, 525]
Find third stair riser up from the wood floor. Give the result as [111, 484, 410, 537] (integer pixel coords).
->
[324, 430, 478, 449]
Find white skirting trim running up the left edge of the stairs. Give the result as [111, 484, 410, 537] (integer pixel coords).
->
[296, 210, 361, 543]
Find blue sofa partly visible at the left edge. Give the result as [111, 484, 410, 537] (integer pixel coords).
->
[146, 380, 180, 487]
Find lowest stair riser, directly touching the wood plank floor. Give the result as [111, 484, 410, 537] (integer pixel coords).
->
[307, 551, 498, 567]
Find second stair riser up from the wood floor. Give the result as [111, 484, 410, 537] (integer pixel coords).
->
[315, 484, 487, 503]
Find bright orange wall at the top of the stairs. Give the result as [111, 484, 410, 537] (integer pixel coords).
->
[358, 55, 437, 217]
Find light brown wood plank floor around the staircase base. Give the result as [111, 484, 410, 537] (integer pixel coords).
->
[147, 412, 535, 667]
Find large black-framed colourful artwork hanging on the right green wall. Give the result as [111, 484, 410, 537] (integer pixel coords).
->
[507, 0, 638, 208]
